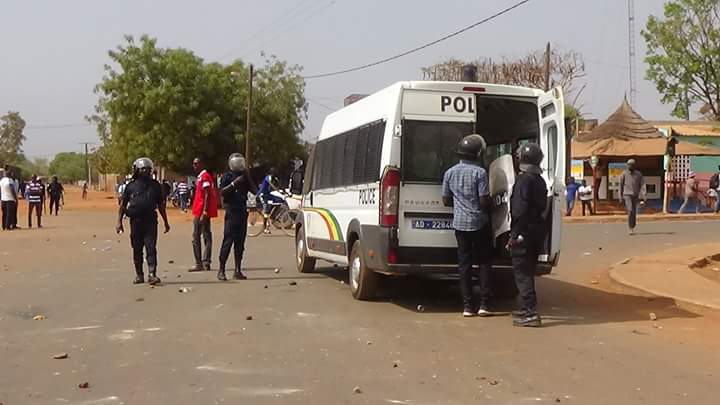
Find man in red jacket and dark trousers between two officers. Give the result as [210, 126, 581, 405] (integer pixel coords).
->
[190, 158, 218, 271]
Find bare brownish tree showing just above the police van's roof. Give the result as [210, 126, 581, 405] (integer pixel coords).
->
[422, 48, 585, 110]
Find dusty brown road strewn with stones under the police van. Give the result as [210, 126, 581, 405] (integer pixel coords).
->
[0, 192, 720, 405]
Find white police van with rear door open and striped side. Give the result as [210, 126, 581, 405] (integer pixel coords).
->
[296, 81, 565, 299]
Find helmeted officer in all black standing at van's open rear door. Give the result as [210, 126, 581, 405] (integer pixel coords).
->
[508, 143, 547, 327]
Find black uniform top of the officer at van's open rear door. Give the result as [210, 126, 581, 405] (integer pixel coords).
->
[510, 173, 547, 240]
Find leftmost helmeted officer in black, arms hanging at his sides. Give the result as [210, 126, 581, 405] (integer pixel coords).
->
[115, 158, 170, 285]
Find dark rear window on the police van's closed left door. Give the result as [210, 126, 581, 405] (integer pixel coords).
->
[401, 120, 473, 184]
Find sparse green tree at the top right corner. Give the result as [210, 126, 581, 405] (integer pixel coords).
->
[642, 0, 720, 120]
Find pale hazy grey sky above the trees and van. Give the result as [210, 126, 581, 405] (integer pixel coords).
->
[0, 0, 671, 158]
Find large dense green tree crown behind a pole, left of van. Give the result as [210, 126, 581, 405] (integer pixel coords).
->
[89, 36, 306, 173]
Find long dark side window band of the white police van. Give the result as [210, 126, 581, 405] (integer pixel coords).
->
[312, 121, 385, 190]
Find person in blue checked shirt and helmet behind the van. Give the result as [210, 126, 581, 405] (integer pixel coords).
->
[442, 134, 492, 317]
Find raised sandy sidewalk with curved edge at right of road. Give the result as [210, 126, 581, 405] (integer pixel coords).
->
[610, 243, 720, 309]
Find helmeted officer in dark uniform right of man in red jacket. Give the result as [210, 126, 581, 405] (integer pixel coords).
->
[217, 153, 257, 281]
